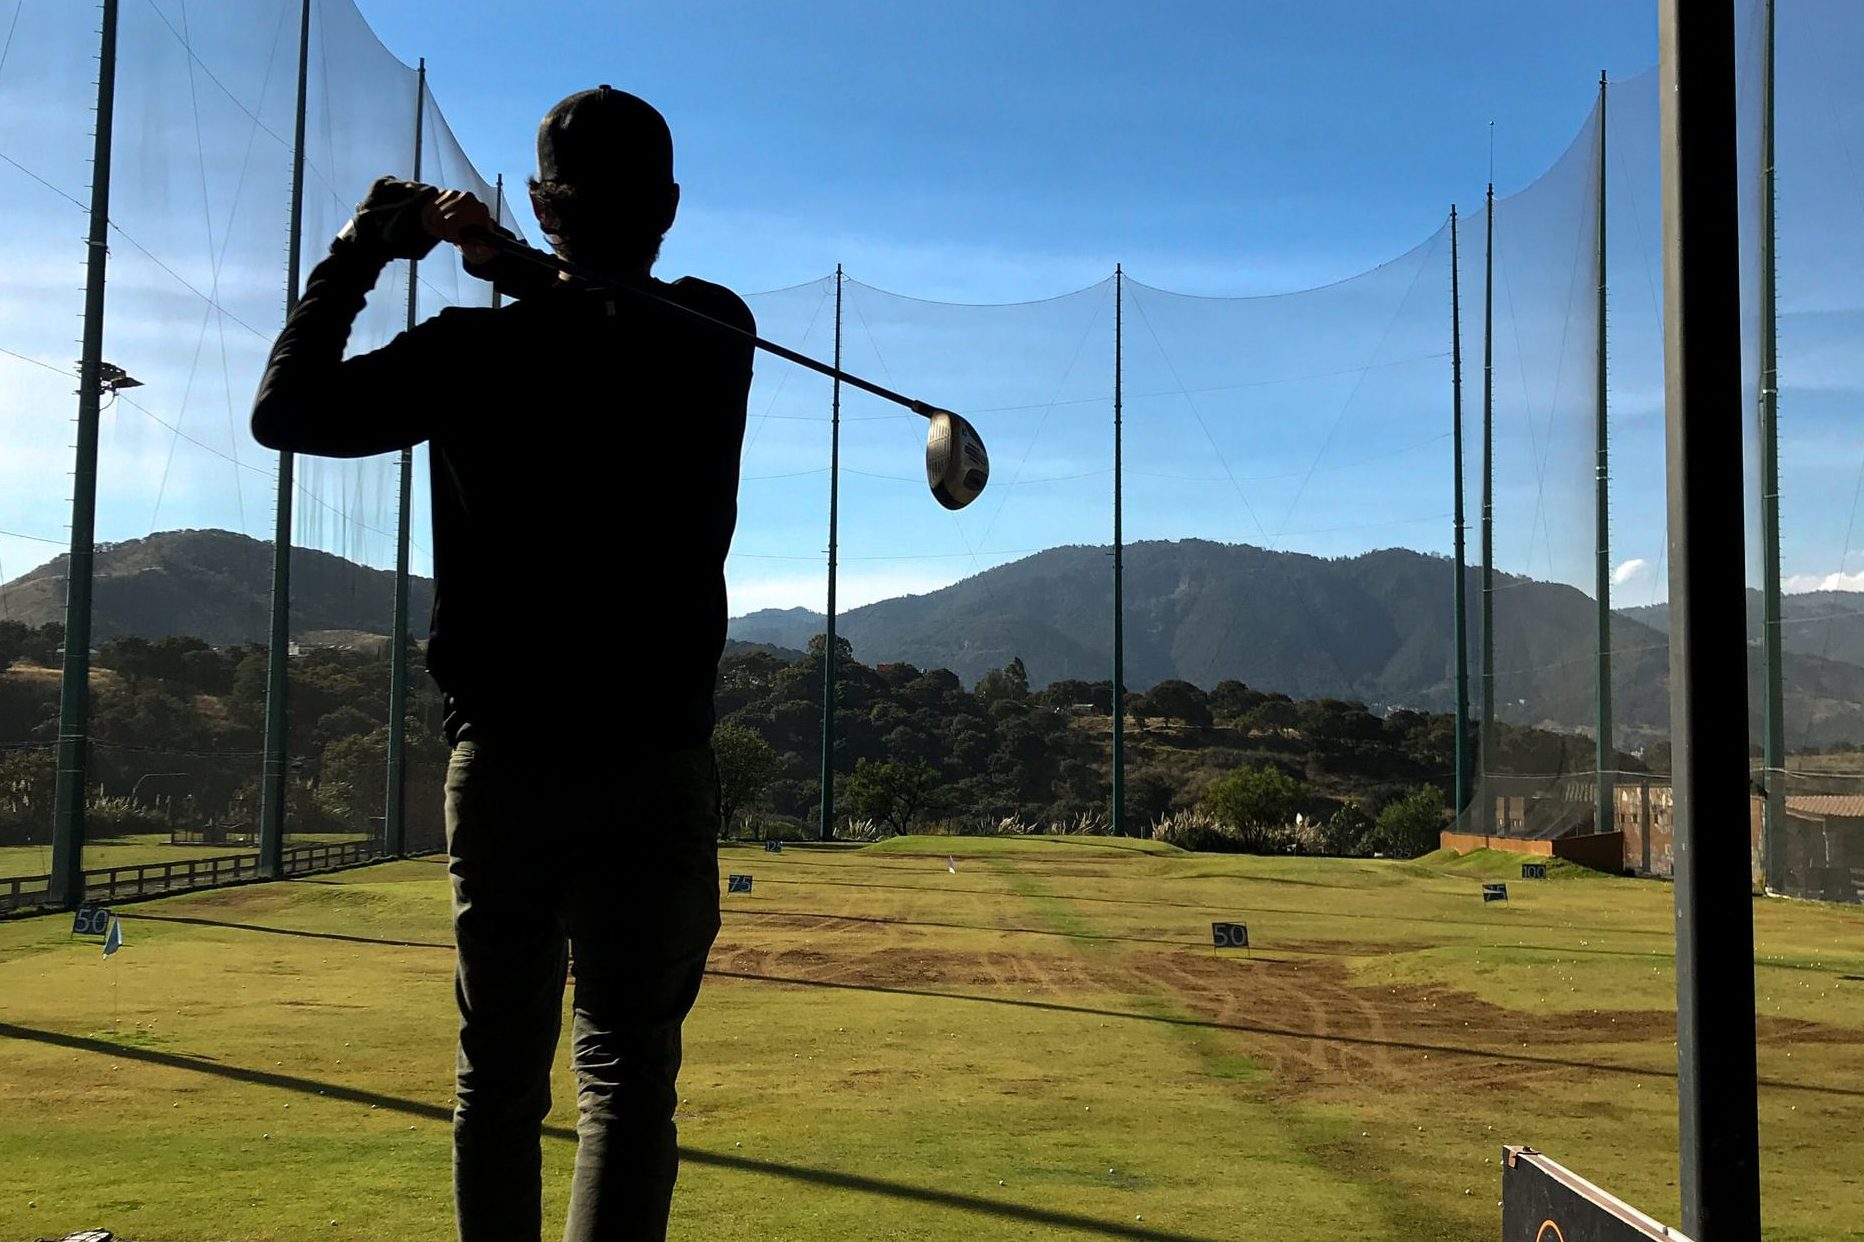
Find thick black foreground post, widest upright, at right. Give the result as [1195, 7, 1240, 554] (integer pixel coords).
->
[1657, 0, 1761, 1242]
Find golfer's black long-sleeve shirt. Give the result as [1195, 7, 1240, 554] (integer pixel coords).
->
[252, 246, 755, 746]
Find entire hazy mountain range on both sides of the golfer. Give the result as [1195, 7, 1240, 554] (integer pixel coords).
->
[0, 530, 1864, 746]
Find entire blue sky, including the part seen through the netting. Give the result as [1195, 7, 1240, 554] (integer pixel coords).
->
[0, 0, 1864, 612]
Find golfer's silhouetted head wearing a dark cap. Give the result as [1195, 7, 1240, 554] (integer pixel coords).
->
[531, 86, 680, 274]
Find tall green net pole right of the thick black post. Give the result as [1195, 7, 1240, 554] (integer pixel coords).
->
[1760, 0, 1786, 888]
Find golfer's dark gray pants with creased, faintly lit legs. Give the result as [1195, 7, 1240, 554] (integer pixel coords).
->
[447, 738, 720, 1242]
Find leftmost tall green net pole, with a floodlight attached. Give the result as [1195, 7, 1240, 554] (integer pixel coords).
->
[47, 0, 117, 906]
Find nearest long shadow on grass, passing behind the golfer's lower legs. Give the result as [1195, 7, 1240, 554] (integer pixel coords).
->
[0, 1022, 1217, 1242]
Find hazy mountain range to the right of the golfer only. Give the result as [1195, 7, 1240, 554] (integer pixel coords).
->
[731, 539, 1864, 746]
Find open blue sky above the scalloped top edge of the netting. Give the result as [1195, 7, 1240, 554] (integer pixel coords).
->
[378, 0, 1657, 302]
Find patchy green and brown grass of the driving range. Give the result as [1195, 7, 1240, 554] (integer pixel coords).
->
[0, 837, 1864, 1242]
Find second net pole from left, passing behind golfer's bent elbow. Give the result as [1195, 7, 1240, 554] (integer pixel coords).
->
[259, 0, 311, 880]
